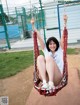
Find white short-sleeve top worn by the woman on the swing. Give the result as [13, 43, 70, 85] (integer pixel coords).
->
[43, 47, 64, 74]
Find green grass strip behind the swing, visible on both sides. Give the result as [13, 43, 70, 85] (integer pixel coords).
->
[0, 48, 79, 79]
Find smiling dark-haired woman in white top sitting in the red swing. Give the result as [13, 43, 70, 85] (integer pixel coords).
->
[31, 15, 67, 90]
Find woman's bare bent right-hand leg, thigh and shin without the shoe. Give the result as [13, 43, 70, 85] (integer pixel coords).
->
[46, 56, 62, 85]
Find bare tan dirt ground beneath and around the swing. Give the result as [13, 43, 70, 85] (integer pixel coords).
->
[0, 54, 80, 105]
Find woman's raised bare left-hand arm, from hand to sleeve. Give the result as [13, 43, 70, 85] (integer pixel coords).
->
[31, 18, 45, 50]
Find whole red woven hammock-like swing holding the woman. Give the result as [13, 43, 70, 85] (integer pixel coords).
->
[33, 27, 68, 96]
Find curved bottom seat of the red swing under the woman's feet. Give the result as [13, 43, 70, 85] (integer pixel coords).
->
[34, 64, 68, 96]
